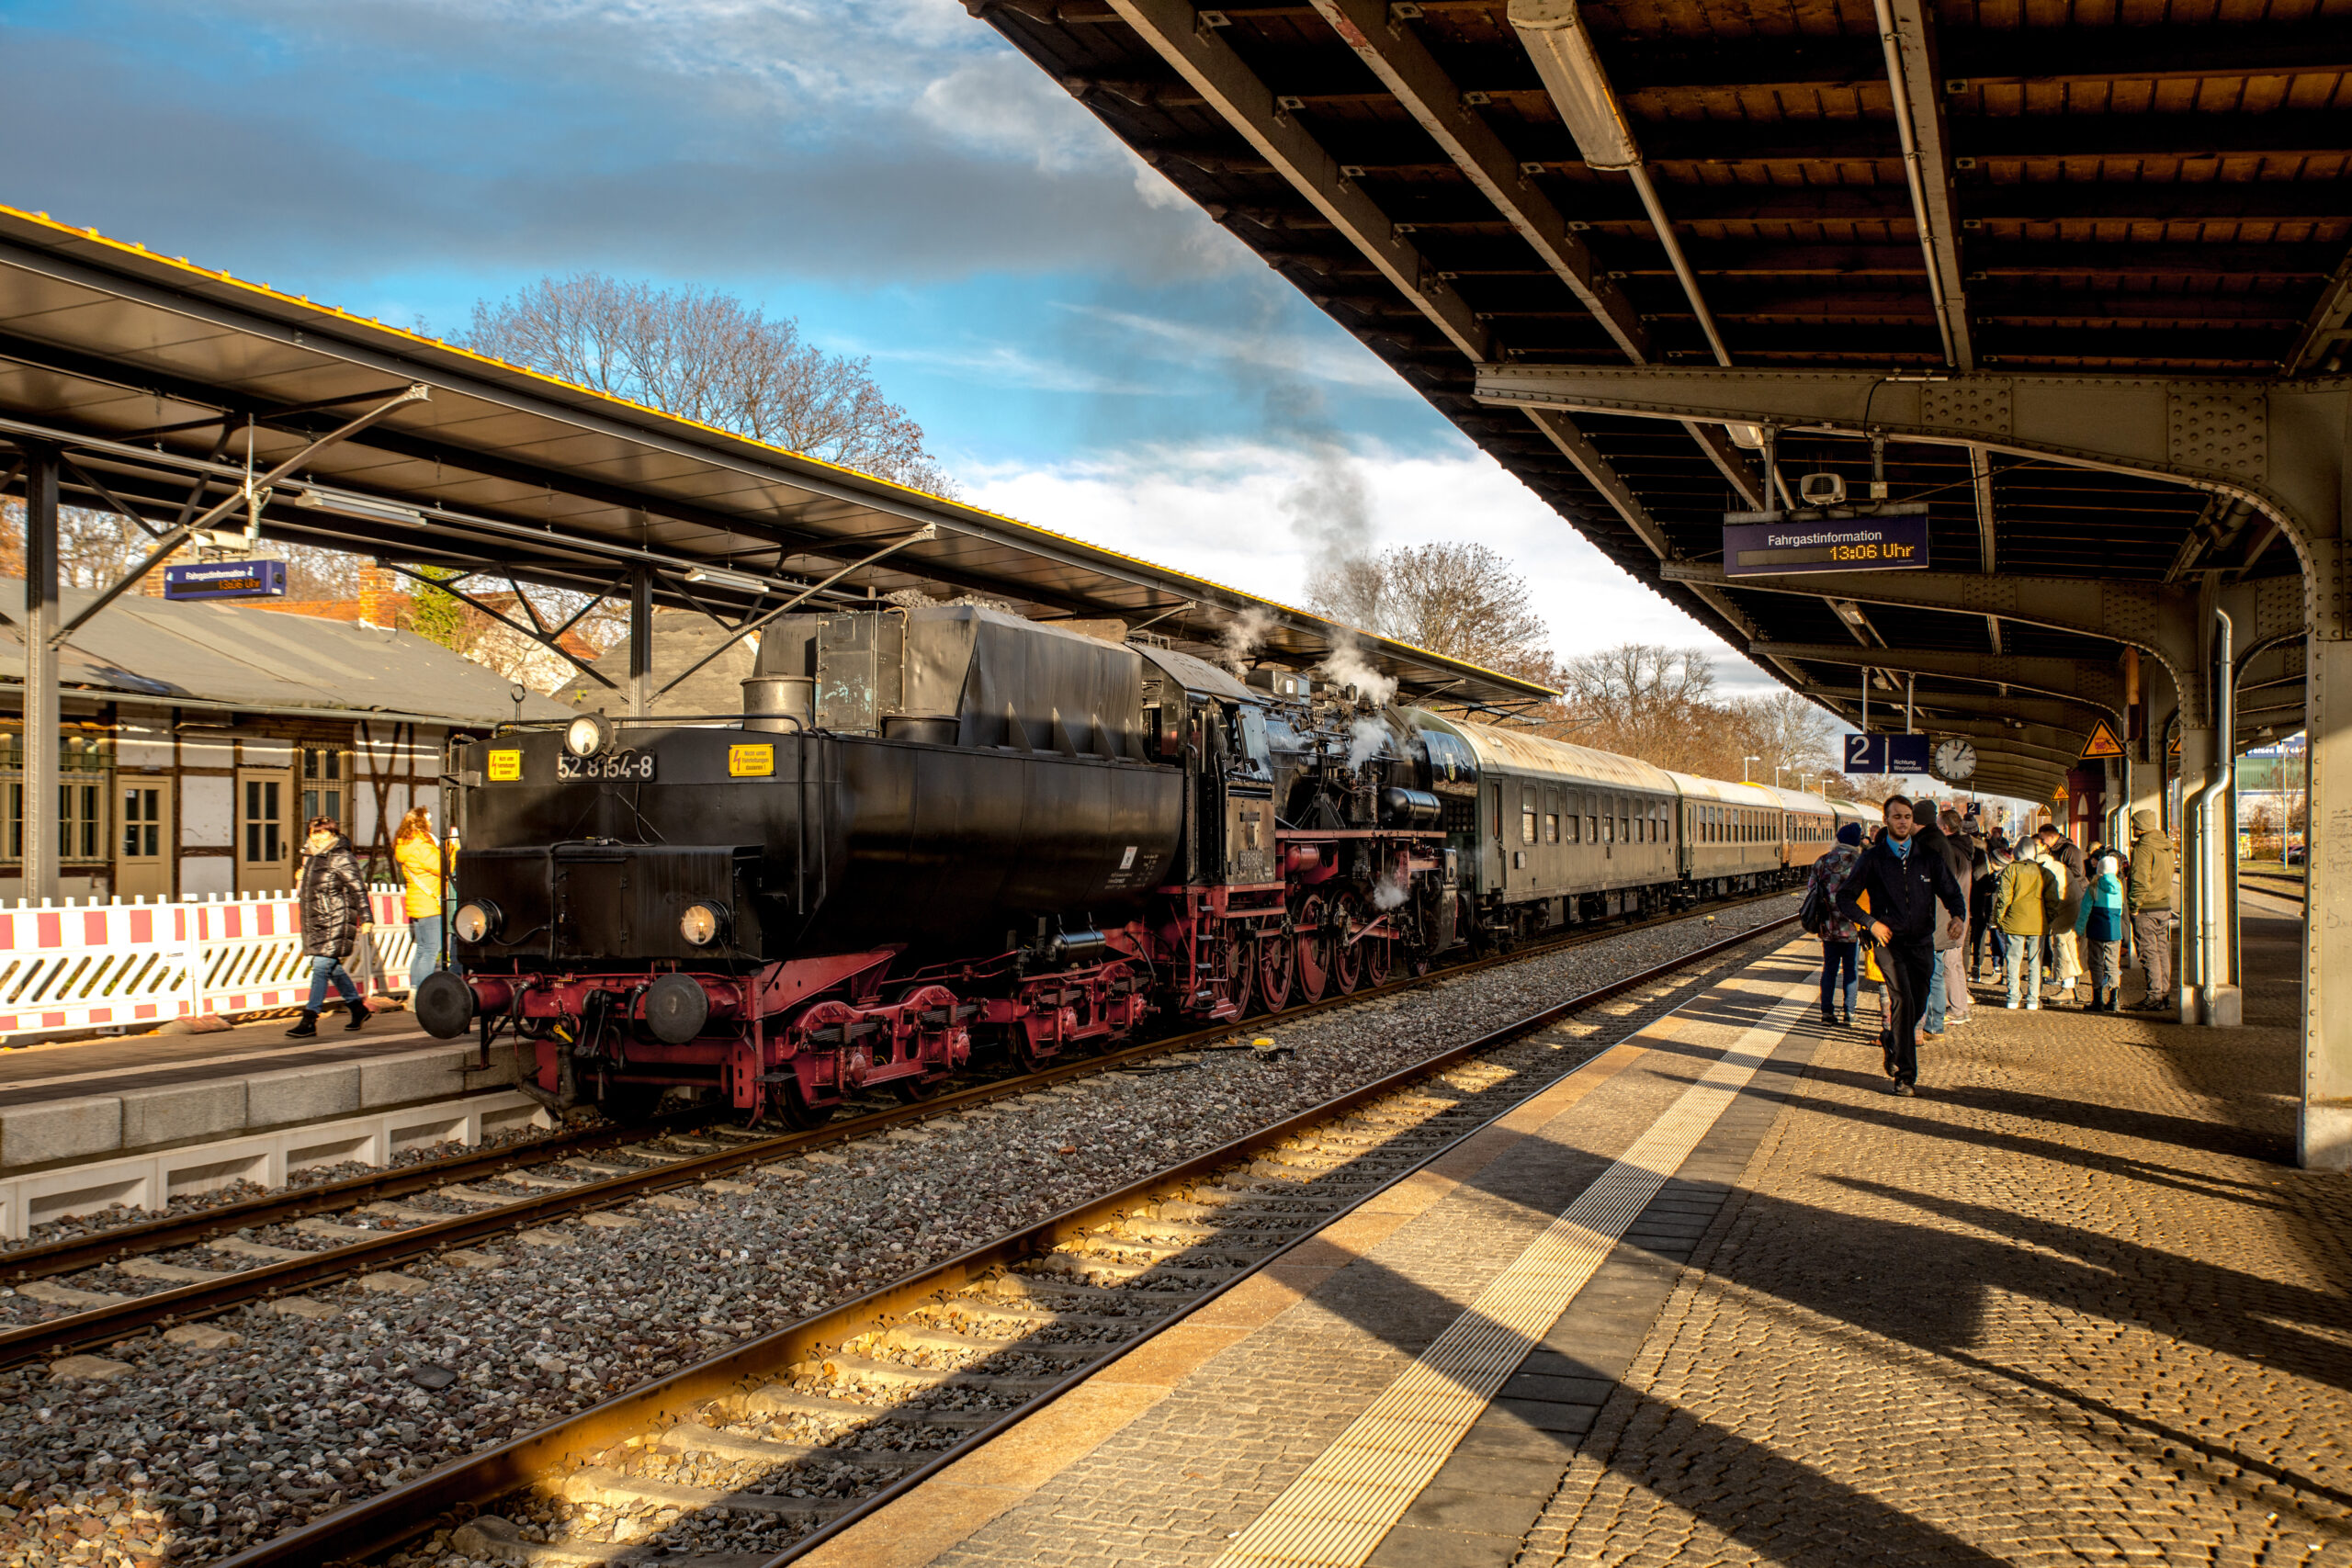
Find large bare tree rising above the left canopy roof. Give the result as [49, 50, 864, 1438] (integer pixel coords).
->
[461, 273, 955, 493]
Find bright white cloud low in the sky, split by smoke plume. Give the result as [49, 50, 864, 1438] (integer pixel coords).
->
[957, 442, 1771, 677]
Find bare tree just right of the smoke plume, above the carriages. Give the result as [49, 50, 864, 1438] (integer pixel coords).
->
[1307, 541, 1553, 680]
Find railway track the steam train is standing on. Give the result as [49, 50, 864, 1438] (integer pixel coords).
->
[0, 894, 1785, 1368]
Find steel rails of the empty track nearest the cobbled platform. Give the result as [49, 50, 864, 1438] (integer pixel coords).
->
[219, 915, 1797, 1568]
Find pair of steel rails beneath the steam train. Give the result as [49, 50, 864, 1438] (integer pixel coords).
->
[0, 888, 1785, 1368]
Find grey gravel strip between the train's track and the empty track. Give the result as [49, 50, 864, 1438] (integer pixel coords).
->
[0, 898, 1794, 1568]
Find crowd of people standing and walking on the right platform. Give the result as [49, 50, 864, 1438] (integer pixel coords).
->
[1804, 795, 2176, 1096]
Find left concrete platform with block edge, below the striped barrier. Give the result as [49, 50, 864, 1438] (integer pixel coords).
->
[0, 1013, 515, 1180]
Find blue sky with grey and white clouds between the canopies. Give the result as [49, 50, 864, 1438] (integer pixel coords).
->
[0, 0, 1764, 689]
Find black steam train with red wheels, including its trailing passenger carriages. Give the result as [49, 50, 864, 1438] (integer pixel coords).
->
[416, 604, 1851, 1126]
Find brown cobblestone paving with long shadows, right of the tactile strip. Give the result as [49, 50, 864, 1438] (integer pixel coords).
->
[1517, 908, 2352, 1568]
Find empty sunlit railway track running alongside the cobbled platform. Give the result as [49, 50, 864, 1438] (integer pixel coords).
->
[211, 917, 1792, 1568]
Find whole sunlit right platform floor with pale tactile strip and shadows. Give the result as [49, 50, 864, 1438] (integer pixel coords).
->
[805, 894, 2352, 1568]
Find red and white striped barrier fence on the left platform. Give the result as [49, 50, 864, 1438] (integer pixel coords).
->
[0, 886, 416, 1037]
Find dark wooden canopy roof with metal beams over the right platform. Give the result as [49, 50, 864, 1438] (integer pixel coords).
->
[967, 0, 2352, 799]
